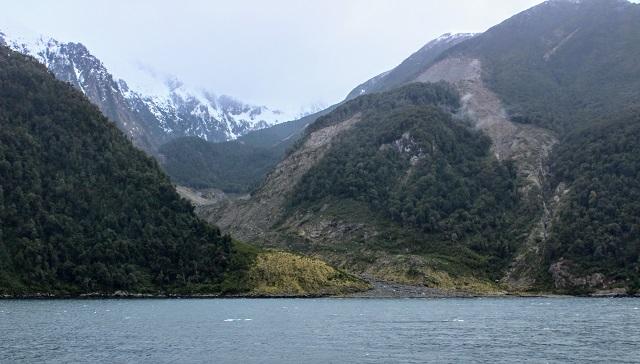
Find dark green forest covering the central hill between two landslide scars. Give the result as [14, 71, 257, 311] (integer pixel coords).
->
[291, 84, 533, 272]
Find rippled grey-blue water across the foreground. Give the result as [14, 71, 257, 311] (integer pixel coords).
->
[0, 298, 640, 364]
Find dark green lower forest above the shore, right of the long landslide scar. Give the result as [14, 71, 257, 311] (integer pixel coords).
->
[548, 112, 640, 284]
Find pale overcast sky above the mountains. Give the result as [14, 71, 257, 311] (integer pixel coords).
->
[0, 0, 552, 111]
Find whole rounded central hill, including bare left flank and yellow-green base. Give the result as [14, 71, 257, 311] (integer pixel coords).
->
[200, 84, 528, 290]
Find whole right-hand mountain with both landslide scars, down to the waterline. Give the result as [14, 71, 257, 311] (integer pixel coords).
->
[199, 0, 640, 293]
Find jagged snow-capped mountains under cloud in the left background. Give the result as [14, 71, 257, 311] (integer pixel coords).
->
[0, 27, 295, 154]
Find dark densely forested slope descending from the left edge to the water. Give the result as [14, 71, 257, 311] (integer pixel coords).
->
[0, 47, 241, 294]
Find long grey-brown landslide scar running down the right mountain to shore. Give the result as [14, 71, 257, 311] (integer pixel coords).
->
[416, 57, 566, 290]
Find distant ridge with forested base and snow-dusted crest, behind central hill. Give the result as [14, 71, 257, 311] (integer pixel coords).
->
[160, 34, 474, 193]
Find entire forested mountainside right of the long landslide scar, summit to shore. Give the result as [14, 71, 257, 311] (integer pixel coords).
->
[438, 0, 640, 286]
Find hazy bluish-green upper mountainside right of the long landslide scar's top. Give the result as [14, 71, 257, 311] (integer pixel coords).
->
[452, 0, 640, 133]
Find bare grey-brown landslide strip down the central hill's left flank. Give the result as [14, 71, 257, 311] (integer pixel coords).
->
[199, 114, 360, 241]
